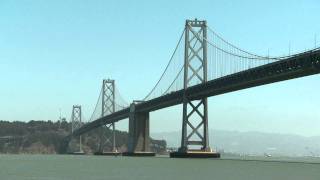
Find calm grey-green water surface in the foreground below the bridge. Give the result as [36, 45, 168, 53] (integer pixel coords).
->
[0, 155, 320, 180]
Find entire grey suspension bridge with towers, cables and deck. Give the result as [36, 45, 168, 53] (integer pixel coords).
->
[66, 19, 320, 157]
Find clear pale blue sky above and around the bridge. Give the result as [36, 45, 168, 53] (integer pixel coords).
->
[0, 0, 320, 136]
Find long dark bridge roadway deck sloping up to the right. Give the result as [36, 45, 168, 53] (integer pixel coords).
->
[69, 49, 320, 138]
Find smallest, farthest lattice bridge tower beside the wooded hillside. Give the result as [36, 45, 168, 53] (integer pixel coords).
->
[71, 105, 83, 152]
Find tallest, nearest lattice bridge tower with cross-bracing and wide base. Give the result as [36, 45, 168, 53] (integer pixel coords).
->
[170, 19, 219, 157]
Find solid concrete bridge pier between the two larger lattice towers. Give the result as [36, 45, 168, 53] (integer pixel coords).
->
[122, 103, 155, 156]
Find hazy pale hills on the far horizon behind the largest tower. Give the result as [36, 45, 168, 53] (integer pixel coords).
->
[152, 130, 320, 156]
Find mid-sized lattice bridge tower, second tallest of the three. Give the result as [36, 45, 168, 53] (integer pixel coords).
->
[94, 79, 120, 155]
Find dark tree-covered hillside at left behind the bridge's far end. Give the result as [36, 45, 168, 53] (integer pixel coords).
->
[0, 121, 166, 154]
